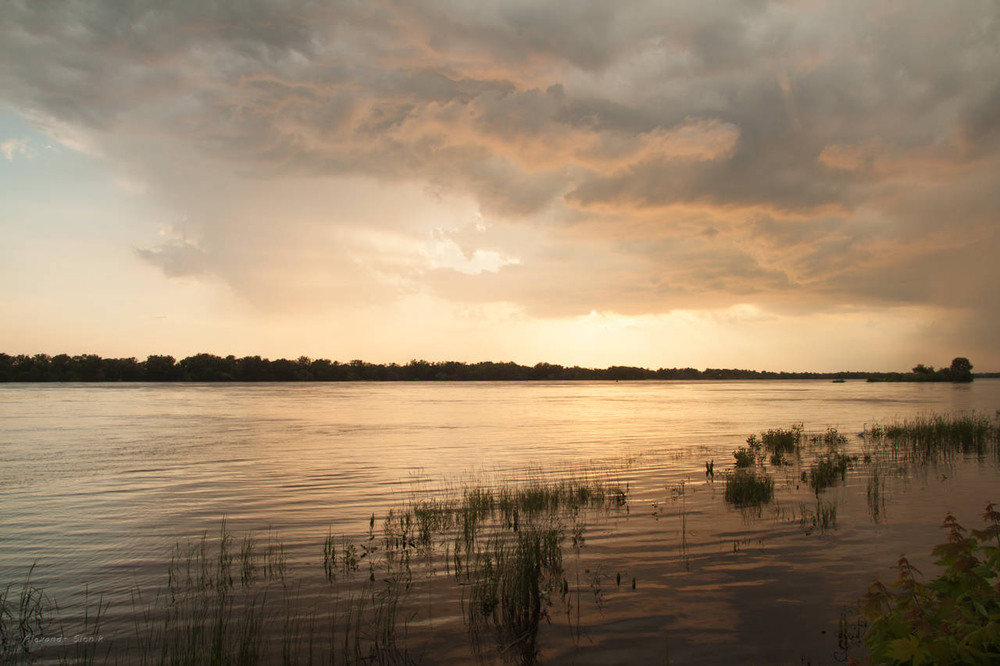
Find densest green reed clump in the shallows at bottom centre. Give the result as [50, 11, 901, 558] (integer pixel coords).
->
[394, 474, 629, 664]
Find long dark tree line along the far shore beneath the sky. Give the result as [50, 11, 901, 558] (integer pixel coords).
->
[0, 353, 972, 382]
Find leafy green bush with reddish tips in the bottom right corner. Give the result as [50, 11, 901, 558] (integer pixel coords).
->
[862, 503, 1000, 665]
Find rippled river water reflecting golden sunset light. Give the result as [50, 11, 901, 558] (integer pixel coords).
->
[0, 380, 1000, 663]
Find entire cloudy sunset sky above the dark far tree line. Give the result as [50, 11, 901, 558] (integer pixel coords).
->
[0, 0, 1000, 371]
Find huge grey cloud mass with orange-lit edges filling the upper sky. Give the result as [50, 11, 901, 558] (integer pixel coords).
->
[0, 0, 1000, 364]
